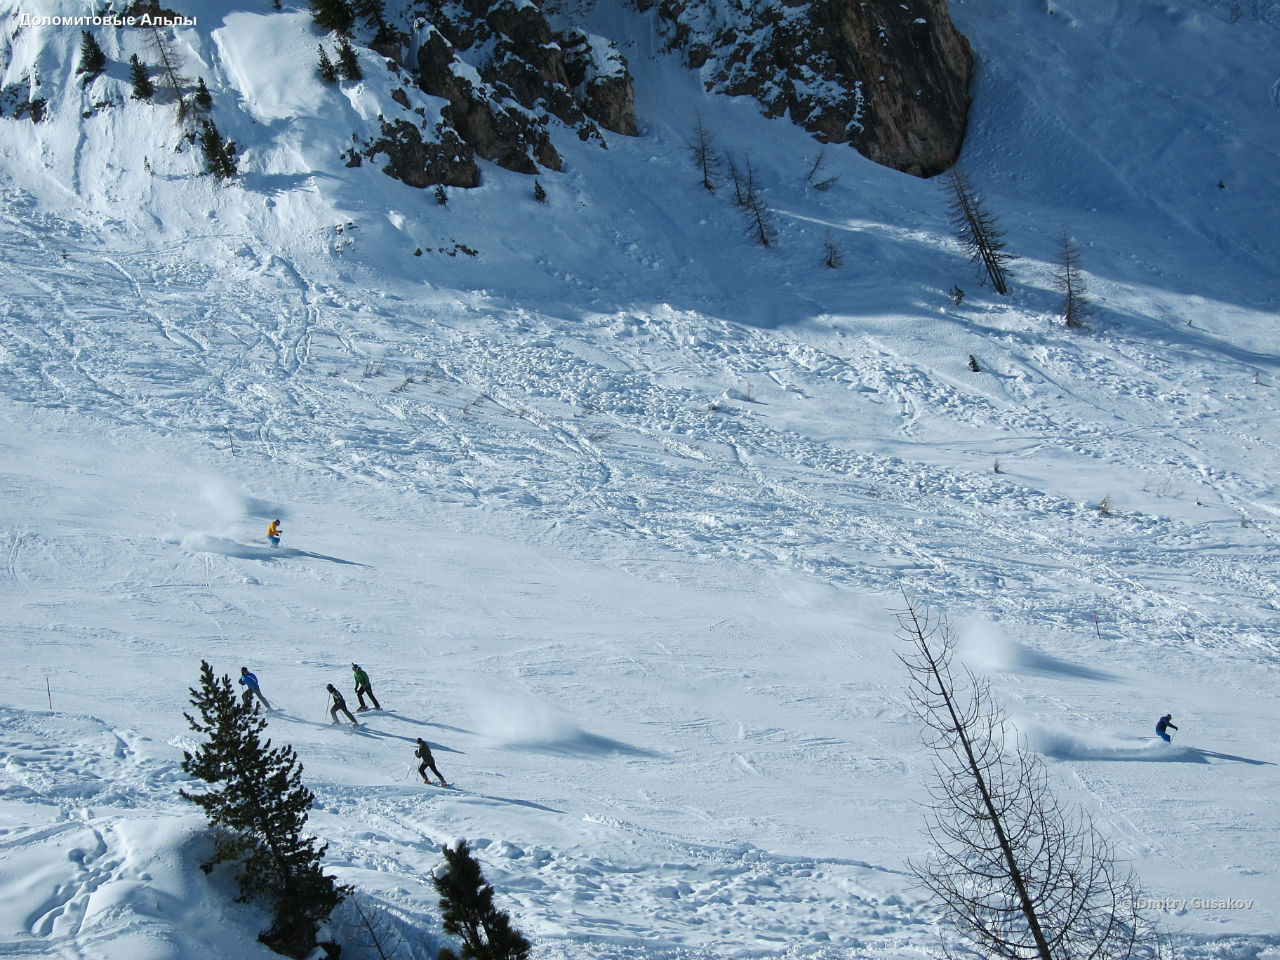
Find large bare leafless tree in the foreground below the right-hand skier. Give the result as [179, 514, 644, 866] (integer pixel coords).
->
[899, 594, 1164, 960]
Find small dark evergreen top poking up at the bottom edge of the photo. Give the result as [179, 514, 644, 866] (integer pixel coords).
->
[434, 840, 530, 960]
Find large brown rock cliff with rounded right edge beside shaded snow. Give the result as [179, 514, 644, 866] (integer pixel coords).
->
[639, 0, 973, 177]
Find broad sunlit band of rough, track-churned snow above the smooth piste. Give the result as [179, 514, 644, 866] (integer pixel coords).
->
[4, 203, 1276, 658]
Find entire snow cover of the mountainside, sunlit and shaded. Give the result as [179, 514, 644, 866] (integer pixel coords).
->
[0, 0, 1280, 960]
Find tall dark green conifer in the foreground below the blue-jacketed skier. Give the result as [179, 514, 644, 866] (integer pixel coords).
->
[179, 665, 347, 957]
